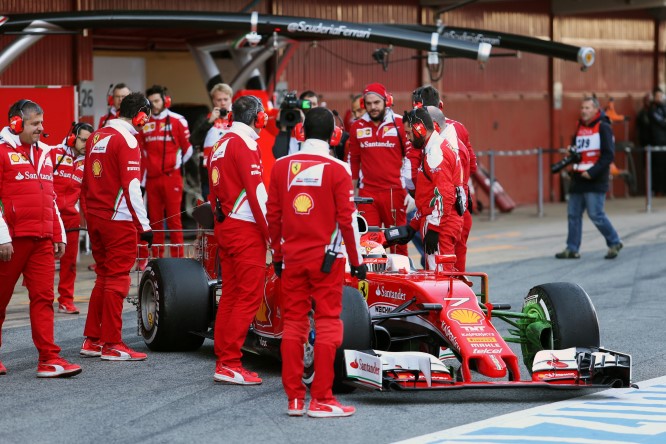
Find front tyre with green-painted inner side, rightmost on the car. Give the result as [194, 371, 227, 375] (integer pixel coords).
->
[522, 282, 599, 373]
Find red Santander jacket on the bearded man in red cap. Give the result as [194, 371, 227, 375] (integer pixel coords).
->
[349, 108, 412, 191]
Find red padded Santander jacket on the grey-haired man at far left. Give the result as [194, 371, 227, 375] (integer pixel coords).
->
[0, 127, 66, 244]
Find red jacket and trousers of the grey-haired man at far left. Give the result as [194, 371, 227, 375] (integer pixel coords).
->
[0, 127, 65, 361]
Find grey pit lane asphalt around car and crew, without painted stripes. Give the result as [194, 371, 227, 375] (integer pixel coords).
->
[0, 199, 666, 443]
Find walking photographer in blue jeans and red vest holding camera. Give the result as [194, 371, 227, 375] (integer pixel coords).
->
[551, 97, 622, 259]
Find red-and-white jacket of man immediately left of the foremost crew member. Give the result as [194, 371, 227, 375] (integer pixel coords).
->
[208, 122, 268, 240]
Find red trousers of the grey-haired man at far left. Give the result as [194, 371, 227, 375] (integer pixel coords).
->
[0, 237, 60, 361]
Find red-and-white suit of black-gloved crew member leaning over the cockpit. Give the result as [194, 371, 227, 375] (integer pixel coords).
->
[410, 133, 463, 271]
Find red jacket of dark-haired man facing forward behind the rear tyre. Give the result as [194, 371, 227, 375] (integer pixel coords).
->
[140, 109, 192, 179]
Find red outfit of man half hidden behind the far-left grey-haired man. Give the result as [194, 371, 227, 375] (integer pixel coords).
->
[51, 145, 85, 304]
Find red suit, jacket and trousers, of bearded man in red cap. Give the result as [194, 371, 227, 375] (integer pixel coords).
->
[349, 108, 412, 255]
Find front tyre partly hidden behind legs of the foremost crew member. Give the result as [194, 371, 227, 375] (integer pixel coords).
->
[303, 286, 372, 393]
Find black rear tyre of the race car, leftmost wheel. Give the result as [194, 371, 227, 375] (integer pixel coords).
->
[137, 258, 210, 351]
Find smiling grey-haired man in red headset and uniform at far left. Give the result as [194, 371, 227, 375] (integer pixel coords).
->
[0, 100, 81, 378]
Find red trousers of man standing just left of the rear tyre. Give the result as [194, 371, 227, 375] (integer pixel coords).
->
[83, 214, 137, 344]
